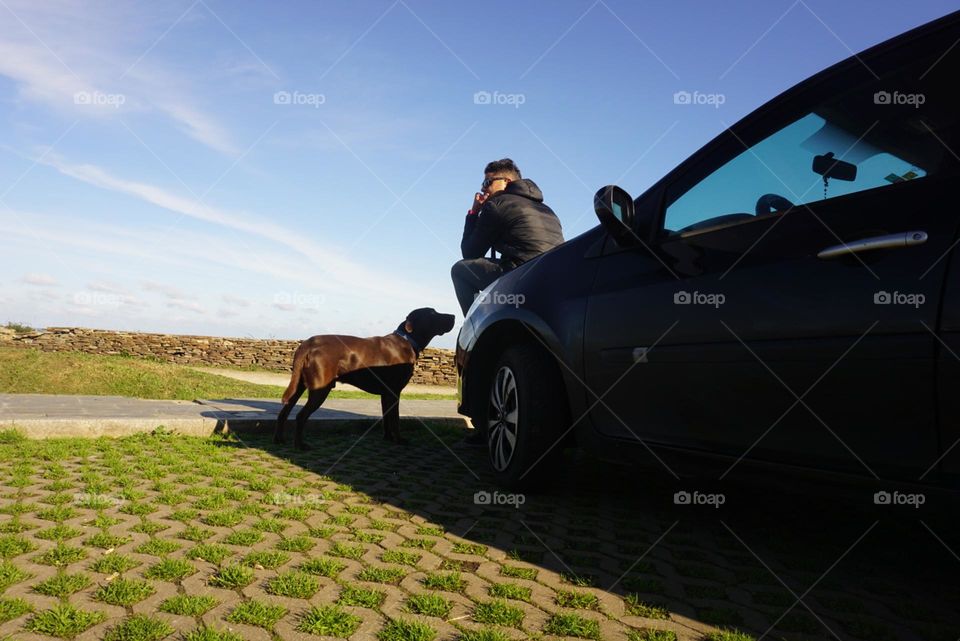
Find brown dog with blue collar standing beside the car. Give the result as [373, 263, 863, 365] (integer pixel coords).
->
[273, 307, 454, 450]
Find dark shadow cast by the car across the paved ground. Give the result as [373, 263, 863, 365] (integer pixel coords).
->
[212, 420, 960, 641]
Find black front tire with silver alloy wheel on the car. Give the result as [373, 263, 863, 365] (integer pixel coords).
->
[483, 345, 569, 489]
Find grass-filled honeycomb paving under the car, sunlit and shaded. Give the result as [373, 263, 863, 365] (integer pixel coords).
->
[0, 424, 960, 641]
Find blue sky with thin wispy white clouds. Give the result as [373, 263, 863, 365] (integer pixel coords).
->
[0, 0, 955, 347]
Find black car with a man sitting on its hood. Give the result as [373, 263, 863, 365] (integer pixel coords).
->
[456, 12, 960, 485]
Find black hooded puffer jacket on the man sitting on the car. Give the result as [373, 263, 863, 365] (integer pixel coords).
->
[460, 178, 563, 268]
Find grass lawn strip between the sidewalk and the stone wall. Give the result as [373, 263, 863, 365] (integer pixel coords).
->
[0, 347, 456, 401]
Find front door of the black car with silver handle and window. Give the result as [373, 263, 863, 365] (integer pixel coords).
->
[585, 13, 958, 476]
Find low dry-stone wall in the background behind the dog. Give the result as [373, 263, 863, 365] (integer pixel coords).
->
[0, 327, 457, 386]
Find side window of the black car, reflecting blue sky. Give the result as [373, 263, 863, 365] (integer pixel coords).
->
[664, 113, 927, 232]
